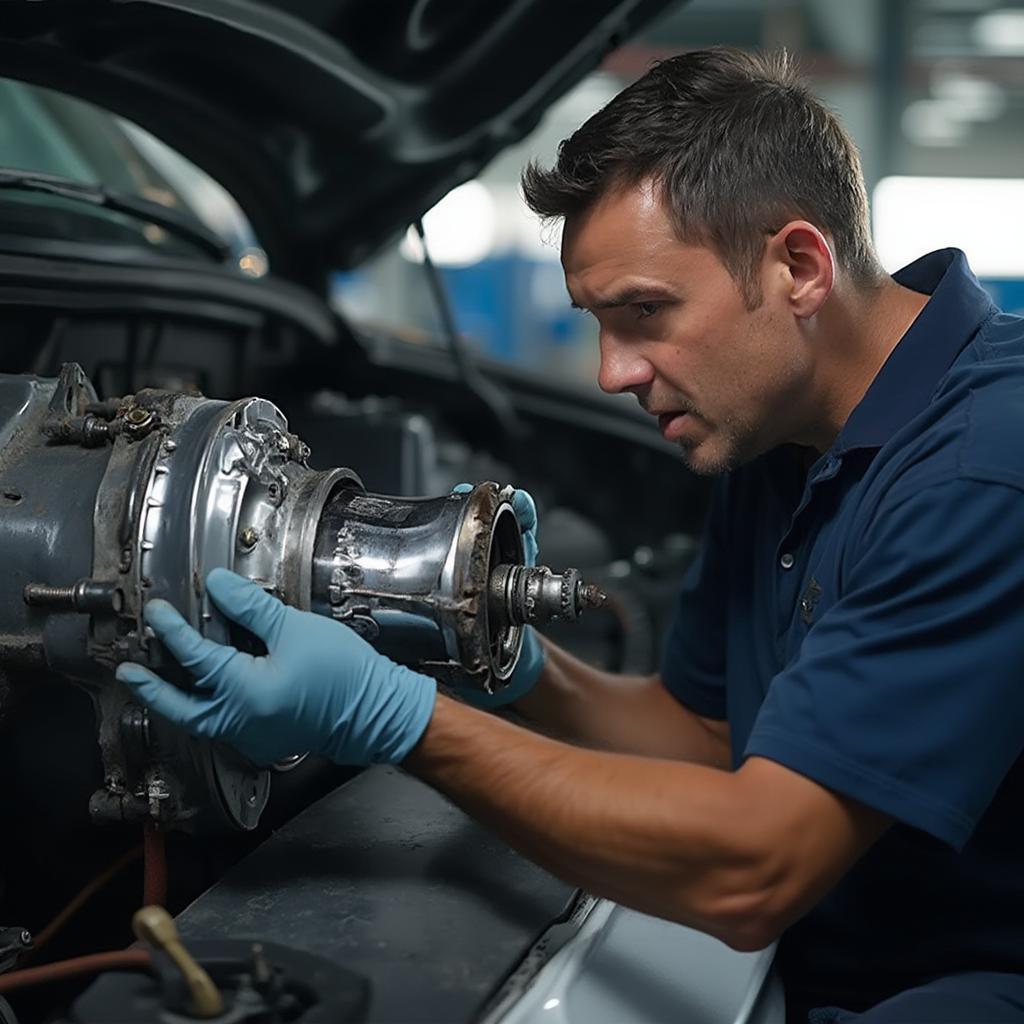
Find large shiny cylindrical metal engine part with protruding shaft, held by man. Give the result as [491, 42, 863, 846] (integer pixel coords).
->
[0, 364, 600, 828]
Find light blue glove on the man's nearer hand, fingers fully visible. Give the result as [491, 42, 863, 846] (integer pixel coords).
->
[117, 569, 437, 765]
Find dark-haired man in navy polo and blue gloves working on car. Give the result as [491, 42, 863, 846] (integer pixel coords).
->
[118, 49, 1024, 1024]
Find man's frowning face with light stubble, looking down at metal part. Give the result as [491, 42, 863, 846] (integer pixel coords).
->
[562, 184, 811, 473]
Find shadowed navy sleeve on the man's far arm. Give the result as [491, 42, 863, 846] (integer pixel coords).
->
[662, 477, 728, 721]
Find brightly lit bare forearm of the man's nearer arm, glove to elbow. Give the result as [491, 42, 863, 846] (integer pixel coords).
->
[406, 697, 760, 941]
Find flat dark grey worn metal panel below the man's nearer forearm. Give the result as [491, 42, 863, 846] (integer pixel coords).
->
[177, 768, 574, 1024]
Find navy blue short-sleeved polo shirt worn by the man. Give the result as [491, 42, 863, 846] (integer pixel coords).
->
[662, 249, 1024, 1005]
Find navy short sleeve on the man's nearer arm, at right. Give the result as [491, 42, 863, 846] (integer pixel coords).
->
[744, 479, 1024, 849]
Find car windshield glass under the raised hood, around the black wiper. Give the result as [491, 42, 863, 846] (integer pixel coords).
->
[0, 79, 266, 276]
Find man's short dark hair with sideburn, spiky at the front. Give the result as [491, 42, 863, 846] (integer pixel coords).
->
[522, 47, 884, 307]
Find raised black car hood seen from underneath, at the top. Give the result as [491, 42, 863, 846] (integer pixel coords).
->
[0, 0, 672, 282]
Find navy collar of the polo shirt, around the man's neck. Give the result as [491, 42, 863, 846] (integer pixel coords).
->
[834, 249, 995, 453]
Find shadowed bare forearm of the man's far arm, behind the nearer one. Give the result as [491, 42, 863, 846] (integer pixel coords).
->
[516, 640, 729, 768]
